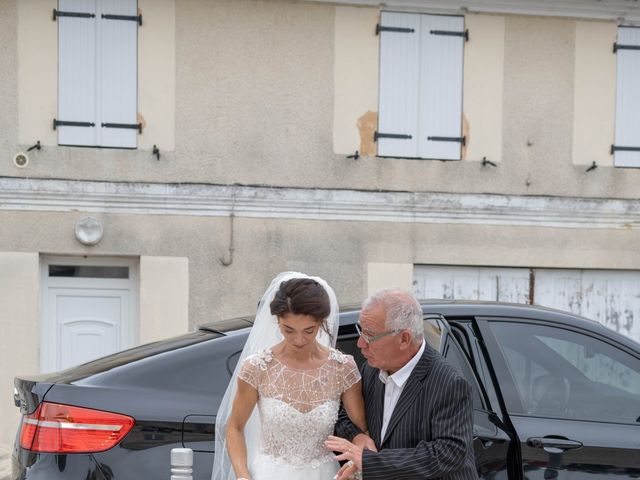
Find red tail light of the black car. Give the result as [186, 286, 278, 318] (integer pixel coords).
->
[20, 402, 135, 453]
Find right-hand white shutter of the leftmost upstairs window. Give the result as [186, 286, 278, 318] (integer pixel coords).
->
[96, 0, 138, 148]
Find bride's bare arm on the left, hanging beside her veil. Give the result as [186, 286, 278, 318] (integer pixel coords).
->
[225, 379, 258, 478]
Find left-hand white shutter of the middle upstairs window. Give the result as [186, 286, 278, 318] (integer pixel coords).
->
[378, 12, 420, 157]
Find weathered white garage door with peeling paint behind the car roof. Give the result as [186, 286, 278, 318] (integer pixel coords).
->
[413, 265, 640, 341]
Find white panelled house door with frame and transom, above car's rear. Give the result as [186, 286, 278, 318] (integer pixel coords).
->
[40, 257, 137, 372]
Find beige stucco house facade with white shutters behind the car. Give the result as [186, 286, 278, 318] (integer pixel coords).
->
[0, 0, 640, 443]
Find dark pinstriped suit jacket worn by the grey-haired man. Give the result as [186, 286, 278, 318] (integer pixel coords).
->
[336, 345, 478, 480]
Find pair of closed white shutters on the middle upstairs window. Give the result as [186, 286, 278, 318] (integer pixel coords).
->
[376, 12, 467, 160]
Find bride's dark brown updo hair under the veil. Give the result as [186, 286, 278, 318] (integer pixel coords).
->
[270, 278, 331, 327]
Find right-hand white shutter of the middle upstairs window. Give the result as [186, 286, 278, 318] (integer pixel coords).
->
[418, 15, 465, 160]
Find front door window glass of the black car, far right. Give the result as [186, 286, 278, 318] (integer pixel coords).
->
[490, 322, 640, 423]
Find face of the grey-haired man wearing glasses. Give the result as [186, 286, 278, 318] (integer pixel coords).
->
[358, 305, 401, 372]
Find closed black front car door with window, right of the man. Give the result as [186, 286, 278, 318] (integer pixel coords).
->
[478, 318, 640, 480]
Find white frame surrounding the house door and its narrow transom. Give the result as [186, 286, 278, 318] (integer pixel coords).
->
[39, 254, 140, 372]
